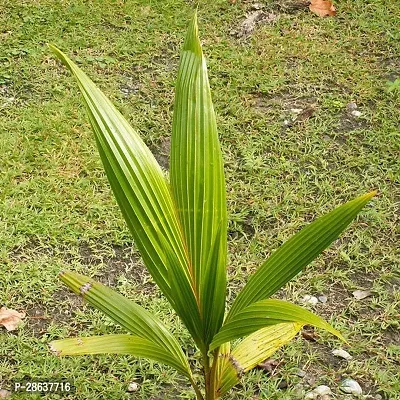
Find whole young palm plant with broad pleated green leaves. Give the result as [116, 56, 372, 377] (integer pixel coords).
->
[50, 16, 375, 400]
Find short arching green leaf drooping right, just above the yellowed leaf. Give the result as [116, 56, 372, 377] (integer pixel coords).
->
[209, 300, 345, 351]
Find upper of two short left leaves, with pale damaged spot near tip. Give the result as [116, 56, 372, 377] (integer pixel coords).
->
[60, 271, 191, 377]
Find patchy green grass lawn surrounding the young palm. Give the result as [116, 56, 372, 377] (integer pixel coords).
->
[0, 0, 400, 400]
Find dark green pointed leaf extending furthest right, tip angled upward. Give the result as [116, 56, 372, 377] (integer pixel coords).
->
[226, 192, 376, 321]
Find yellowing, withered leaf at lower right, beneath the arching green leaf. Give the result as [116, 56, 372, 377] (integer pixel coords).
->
[218, 322, 303, 396]
